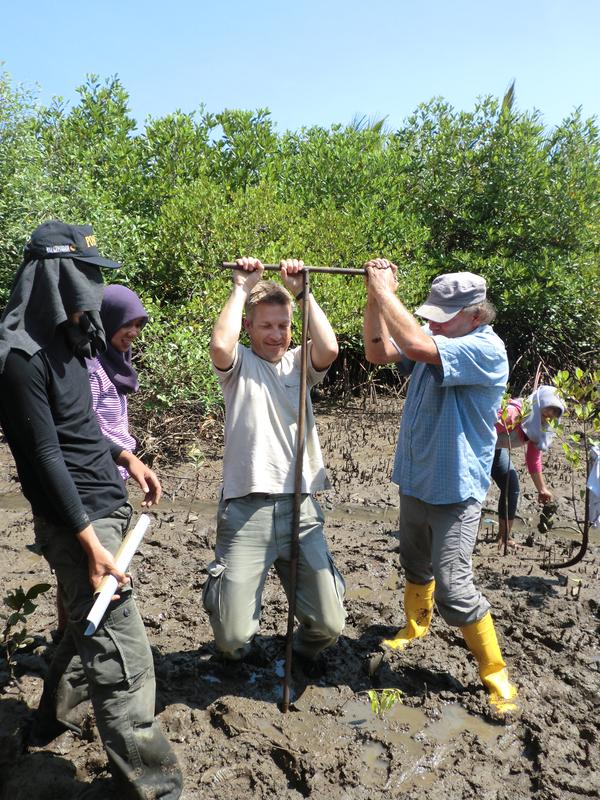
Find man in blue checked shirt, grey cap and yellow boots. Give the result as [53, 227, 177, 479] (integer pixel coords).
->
[364, 258, 517, 716]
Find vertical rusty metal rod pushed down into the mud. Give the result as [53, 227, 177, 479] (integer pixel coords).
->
[282, 270, 310, 714]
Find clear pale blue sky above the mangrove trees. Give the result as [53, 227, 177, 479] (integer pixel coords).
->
[0, 0, 600, 131]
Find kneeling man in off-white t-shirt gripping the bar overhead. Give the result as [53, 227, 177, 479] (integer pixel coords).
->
[203, 258, 345, 660]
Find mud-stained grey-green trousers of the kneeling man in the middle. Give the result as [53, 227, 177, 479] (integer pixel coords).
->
[203, 494, 346, 659]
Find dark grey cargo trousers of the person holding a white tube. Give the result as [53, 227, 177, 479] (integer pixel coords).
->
[35, 505, 183, 800]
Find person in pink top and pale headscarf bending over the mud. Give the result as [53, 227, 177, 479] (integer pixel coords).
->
[492, 386, 564, 547]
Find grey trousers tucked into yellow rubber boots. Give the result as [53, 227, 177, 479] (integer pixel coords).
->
[400, 493, 490, 626]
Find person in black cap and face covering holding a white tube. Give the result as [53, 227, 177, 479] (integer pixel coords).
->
[0, 220, 182, 800]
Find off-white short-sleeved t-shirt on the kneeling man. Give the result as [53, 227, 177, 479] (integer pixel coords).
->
[214, 342, 330, 500]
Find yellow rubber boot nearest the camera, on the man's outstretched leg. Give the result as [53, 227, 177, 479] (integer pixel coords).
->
[461, 611, 519, 717]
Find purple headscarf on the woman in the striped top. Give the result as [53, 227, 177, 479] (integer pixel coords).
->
[98, 283, 148, 394]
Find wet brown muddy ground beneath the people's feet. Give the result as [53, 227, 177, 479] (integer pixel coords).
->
[0, 400, 600, 800]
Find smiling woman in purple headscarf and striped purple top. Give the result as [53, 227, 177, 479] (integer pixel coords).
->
[87, 284, 148, 480]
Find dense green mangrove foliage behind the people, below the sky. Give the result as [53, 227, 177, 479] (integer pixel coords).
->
[0, 74, 600, 418]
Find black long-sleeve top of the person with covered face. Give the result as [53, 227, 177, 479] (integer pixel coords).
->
[0, 328, 127, 533]
